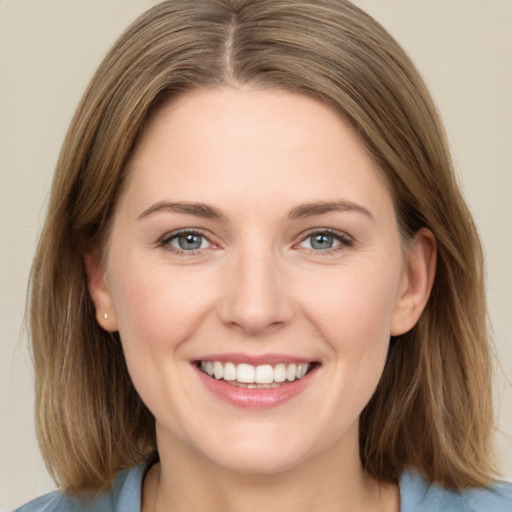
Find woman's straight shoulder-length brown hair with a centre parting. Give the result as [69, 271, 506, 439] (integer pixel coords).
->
[30, 0, 493, 492]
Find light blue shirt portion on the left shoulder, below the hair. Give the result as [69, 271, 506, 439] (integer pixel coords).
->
[13, 464, 145, 512]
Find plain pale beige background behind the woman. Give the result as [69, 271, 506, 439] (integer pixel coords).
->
[0, 0, 512, 512]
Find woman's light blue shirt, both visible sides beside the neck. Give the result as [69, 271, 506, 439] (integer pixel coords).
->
[14, 464, 512, 512]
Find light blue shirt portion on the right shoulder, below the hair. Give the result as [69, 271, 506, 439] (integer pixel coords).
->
[400, 472, 512, 512]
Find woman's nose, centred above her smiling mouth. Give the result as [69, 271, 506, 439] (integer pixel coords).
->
[219, 248, 294, 336]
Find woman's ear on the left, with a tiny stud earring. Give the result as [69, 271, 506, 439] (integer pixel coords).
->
[84, 253, 118, 332]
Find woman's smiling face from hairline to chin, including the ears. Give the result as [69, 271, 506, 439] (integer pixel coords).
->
[89, 87, 432, 472]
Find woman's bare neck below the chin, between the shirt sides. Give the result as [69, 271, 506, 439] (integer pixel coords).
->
[142, 428, 399, 512]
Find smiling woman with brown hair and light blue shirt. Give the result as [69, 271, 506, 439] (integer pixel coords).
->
[16, 0, 512, 512]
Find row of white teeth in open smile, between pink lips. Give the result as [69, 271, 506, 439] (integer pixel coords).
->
[196, 361, 318, 389]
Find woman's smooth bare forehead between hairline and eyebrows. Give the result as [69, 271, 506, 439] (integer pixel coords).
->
[119, 87, 389, 216]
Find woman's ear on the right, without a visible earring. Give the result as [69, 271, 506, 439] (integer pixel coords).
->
[390, 228, 437, 336]
